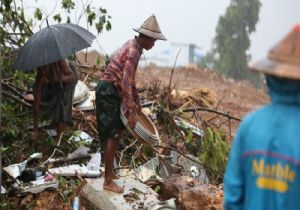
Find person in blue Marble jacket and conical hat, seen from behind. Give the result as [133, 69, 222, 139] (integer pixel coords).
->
[224, 25, 300, 210]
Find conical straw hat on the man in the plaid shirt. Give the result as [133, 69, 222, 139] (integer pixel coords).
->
[133, 15, 167, 40]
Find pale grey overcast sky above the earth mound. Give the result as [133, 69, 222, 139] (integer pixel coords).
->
[26, 0, 300, 64]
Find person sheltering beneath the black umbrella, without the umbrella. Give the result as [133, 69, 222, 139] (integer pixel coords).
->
[32, 59, 78, 143]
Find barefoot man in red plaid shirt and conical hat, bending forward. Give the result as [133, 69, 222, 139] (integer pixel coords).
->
[96, 15, 166, 193]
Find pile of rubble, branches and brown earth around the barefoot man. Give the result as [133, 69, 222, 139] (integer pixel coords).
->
[3, 55, 268, 210]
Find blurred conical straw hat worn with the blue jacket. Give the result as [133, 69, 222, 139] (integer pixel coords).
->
[250, 24, 300, 80]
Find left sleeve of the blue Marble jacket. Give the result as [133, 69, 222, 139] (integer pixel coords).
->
[224, 124, 245, 210]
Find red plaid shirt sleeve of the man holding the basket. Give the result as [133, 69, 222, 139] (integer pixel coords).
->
[122, 50, 139, 113]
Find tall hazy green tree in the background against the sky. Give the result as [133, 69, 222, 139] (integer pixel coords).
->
[202, 0, 261, 85]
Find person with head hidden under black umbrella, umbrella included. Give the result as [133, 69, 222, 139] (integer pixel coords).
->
[15, 23, 96, 143]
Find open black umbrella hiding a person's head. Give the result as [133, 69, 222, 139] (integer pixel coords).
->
[15, 23, 96, 70]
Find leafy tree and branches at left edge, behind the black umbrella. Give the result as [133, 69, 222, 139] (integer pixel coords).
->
[0, 0, 111, 164]
